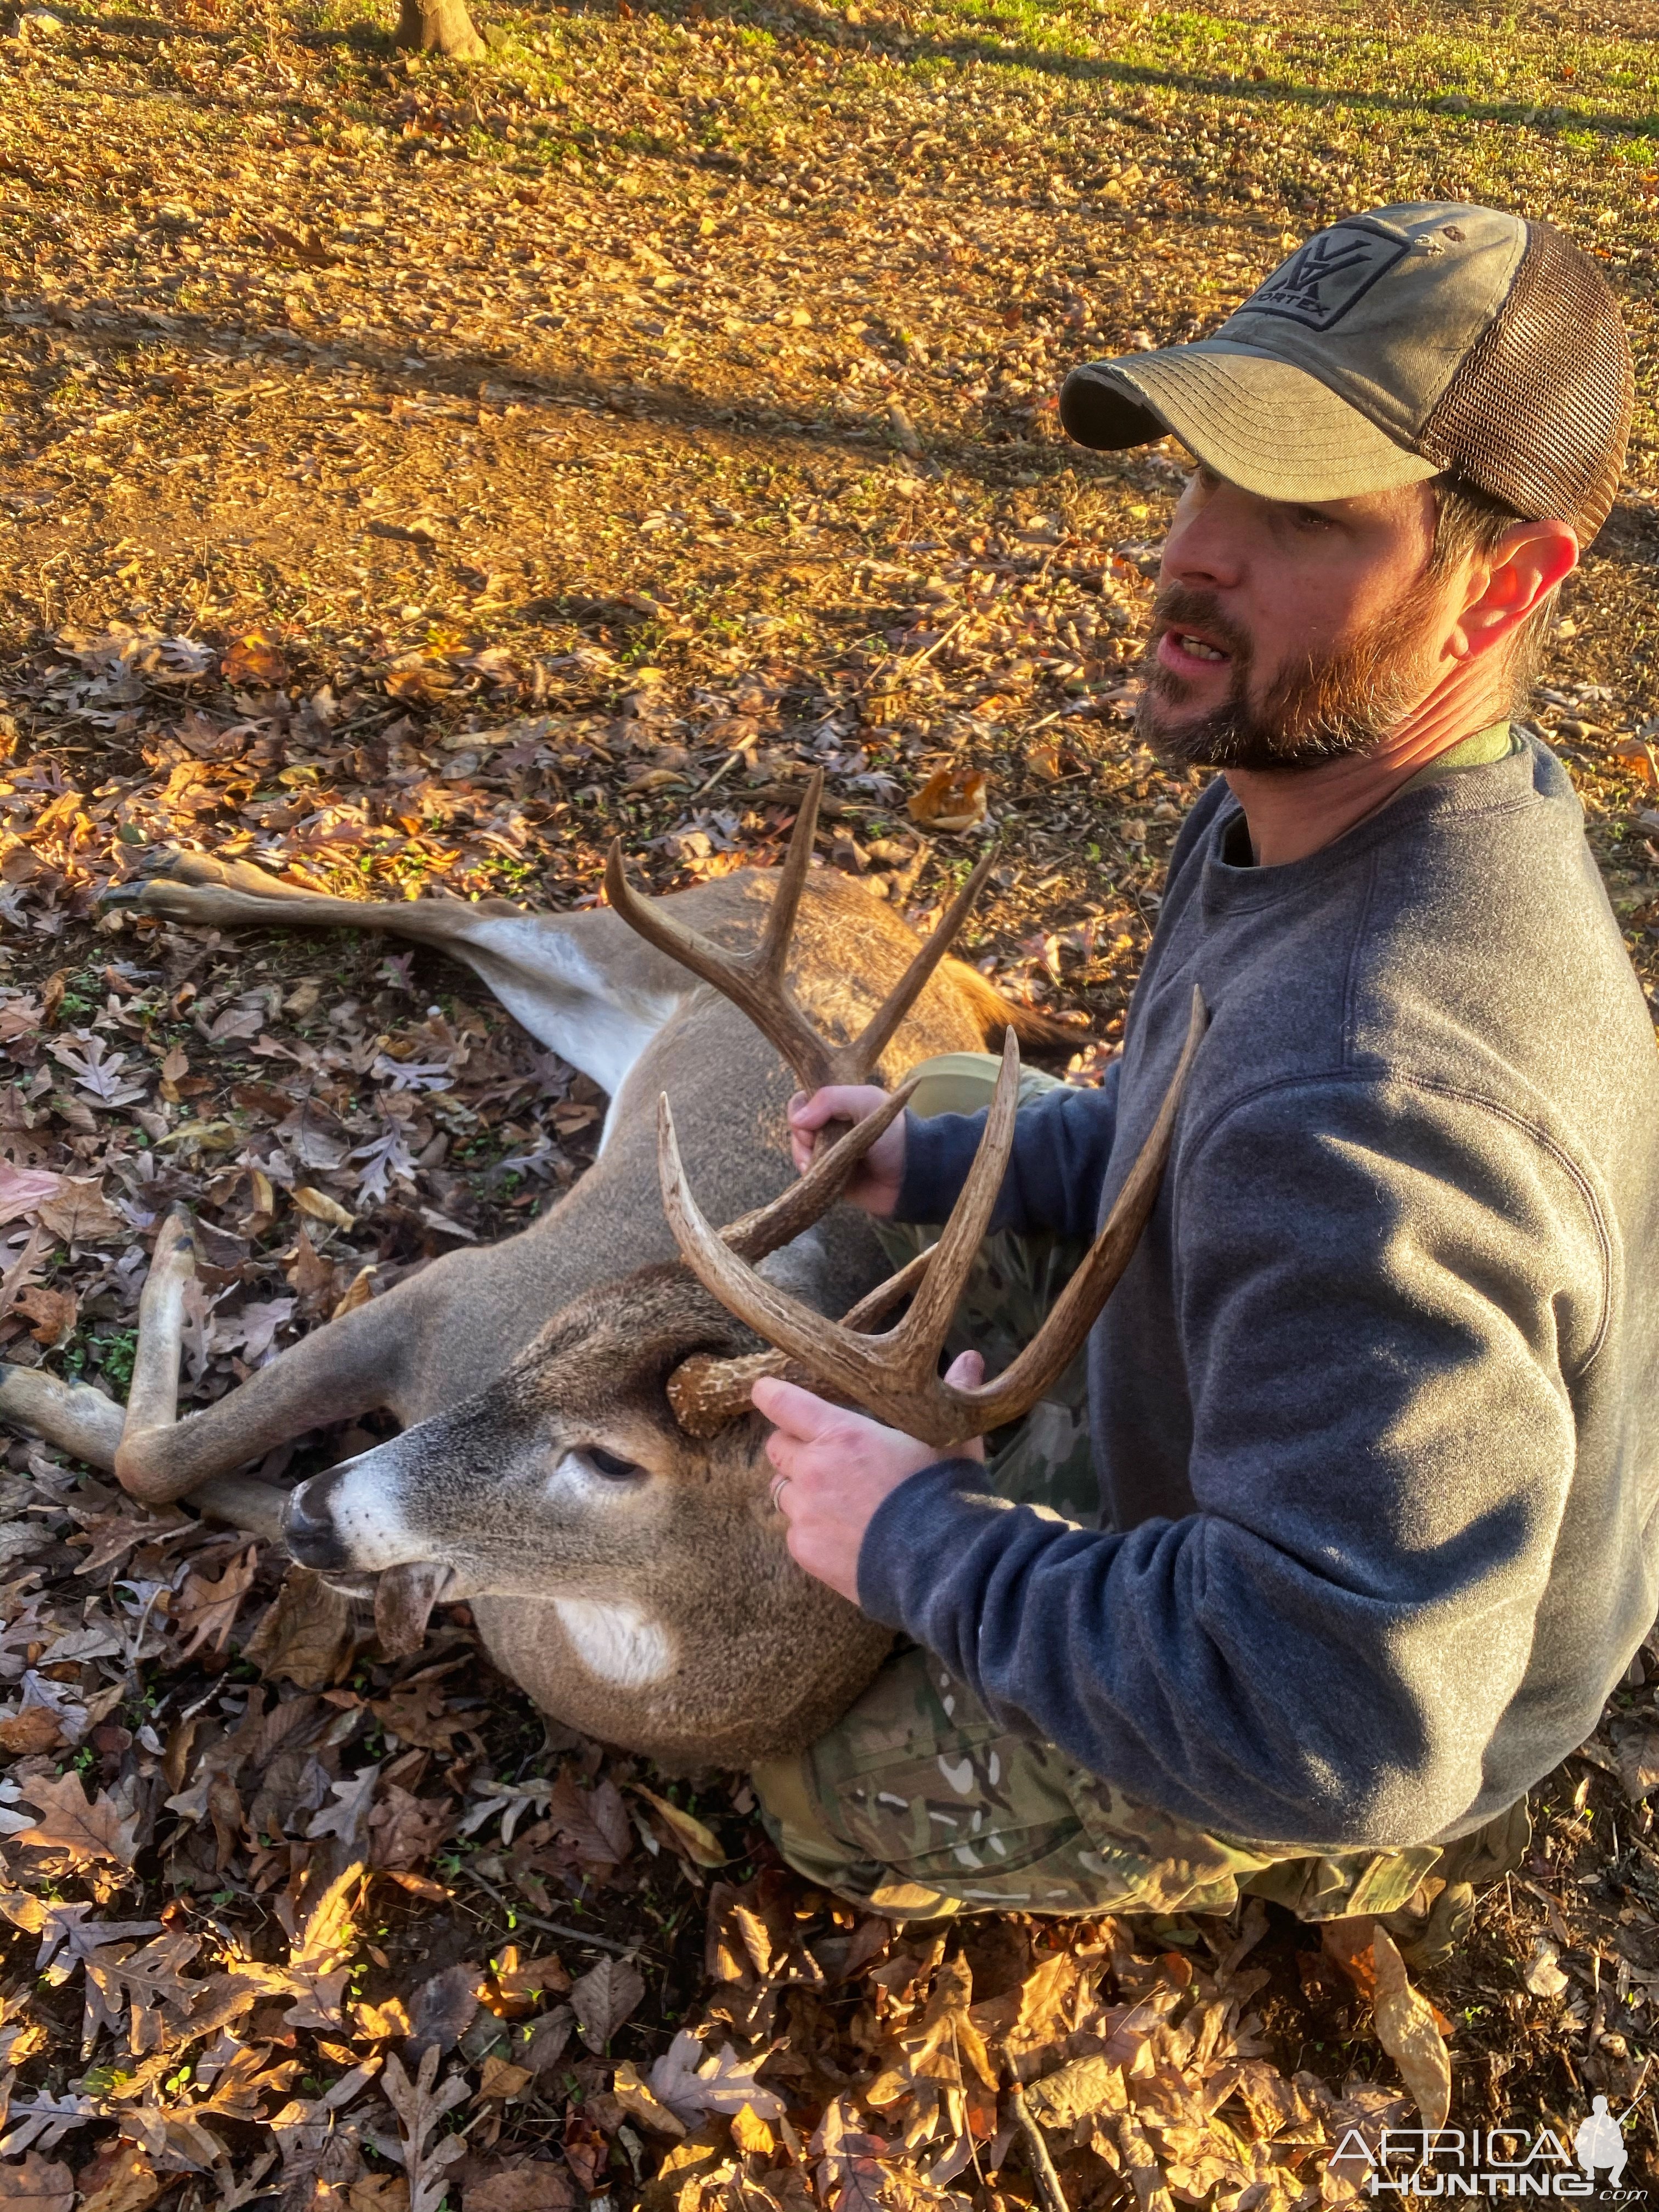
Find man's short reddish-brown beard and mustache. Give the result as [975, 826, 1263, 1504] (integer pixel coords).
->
[1135, 575, 1438, 770]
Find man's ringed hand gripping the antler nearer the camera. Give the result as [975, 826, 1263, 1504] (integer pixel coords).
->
[752, 1353, 984, 1606]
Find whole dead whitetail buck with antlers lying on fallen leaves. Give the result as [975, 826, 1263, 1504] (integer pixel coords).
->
[0, 781, 1203, 1765]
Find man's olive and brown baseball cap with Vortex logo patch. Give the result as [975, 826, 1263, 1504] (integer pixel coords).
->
[1059, 204, 1635, 544]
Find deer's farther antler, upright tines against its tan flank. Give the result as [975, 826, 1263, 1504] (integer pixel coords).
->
[604, 768, 993, 1091]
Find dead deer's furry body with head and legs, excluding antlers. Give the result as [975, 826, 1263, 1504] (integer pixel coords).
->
[0, 854, 1013, 1765]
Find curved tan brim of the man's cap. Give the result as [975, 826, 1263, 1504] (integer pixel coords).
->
[1059, 338, 1440, 500]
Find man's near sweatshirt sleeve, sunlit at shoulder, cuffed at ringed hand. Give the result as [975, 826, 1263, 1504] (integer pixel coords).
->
[858, 1080, 1606, 1849]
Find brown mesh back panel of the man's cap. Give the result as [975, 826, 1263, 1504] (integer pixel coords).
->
[1420, 223, 1635, 544]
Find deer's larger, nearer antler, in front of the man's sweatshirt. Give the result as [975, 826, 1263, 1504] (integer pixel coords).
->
[657, 989, 1210, 1451]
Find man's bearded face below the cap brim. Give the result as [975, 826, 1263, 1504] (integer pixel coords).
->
[1139, 469, 1447, 770]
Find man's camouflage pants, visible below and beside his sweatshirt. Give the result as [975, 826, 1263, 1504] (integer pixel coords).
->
[752, 1053, 1524, 1920]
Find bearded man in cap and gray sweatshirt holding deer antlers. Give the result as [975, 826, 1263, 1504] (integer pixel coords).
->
[754, 206, 1659, 1957]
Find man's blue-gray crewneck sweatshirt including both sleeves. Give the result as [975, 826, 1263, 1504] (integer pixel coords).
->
[858, 743, 1659, 1849]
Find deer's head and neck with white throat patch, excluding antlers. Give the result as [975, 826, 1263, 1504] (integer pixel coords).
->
[285, 1265, 887, 1765]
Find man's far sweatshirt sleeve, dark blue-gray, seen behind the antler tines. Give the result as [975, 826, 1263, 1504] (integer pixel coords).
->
[894, 1059, 1121, 1239]
